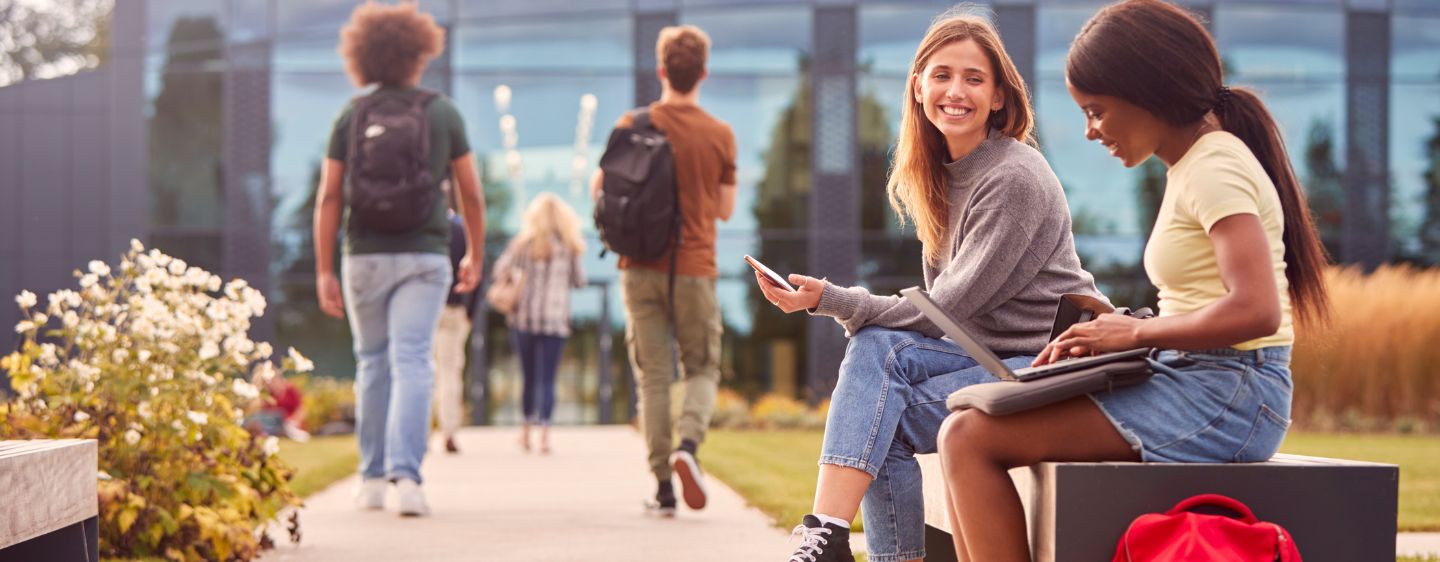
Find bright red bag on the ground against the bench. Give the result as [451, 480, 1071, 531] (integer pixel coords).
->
[1115, 494, 1300, 562]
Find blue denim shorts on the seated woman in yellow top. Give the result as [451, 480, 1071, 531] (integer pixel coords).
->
[1090, 346, 1292, 463]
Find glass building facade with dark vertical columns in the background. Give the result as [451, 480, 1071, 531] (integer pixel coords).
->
[2, 0, 1440, 422]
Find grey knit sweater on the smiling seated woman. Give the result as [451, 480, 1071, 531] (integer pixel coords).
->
[812, 131, 1107, 353]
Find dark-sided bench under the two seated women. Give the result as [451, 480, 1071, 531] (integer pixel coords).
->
[919, 454, 1400, 562]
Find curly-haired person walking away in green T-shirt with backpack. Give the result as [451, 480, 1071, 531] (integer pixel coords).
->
[314, 3, 485, 516]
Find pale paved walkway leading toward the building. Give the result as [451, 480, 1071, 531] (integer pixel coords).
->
[264, 425, 793, 562]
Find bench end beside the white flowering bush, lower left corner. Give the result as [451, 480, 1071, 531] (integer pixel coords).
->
[0, 440, 99, 562]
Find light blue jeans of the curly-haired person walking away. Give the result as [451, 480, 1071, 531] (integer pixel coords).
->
[341, 252, 451, 483]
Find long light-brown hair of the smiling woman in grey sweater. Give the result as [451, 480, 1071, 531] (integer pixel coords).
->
[886, 13, 1035, 264]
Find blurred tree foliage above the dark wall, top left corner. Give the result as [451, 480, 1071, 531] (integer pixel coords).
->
[0, 0, 114, 86]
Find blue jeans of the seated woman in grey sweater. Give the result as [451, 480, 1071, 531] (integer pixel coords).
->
[819, 327, 1034, 562]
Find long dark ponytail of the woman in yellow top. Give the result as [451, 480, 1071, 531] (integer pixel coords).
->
[1215, 88, 1331, 326]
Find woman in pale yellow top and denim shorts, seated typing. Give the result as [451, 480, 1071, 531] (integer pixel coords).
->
[940, 0, 1329, 562]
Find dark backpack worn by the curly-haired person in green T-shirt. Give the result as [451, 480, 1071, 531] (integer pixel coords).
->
[346, 89, 441, 232]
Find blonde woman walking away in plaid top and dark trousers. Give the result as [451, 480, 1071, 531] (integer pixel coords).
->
[494, 193, 585, 454]
